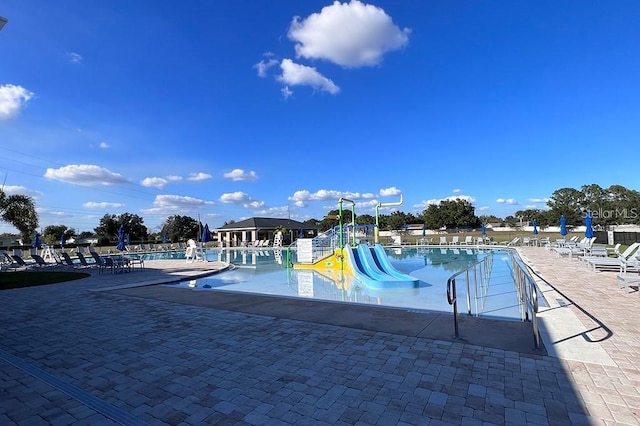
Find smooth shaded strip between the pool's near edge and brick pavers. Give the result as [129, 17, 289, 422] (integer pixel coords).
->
[103, 285, 547, 356]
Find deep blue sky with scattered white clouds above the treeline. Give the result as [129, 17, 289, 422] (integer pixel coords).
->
[0, 0, 640, 232]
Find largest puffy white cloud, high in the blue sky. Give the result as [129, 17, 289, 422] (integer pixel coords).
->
[288, 0, 410, 68]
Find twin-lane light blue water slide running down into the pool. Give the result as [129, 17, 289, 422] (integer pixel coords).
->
[343, 244, 418, 288]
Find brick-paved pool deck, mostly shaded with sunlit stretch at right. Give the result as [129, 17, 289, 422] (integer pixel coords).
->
[0, 247, 640, 425]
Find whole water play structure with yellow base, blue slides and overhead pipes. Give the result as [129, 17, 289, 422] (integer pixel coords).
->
[287, 196, 418, 288]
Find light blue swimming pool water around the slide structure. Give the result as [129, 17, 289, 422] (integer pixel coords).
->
[158, 247, 536, 321]
